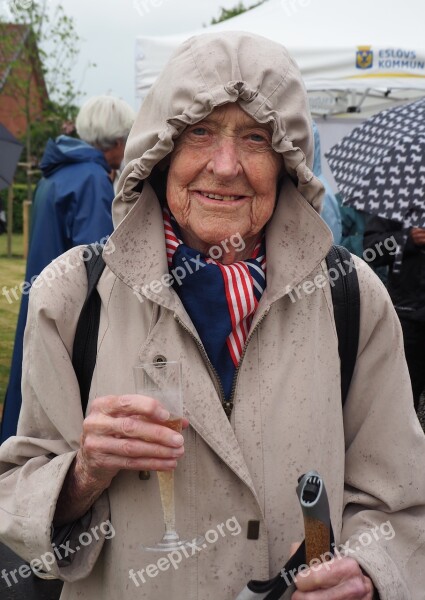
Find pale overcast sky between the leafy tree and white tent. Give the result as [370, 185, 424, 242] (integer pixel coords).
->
[53, 0, 242, 108]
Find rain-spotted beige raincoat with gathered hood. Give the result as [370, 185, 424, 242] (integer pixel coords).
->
[0, 33, 425, 600]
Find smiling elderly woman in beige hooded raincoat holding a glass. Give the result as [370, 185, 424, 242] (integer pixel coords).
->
[0, 32, 425, 600]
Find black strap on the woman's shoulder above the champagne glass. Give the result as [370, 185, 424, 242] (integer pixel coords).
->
[72, 244, 105, 415]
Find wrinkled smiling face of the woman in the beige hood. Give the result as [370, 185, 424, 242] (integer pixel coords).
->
[167, 104, 283, 262]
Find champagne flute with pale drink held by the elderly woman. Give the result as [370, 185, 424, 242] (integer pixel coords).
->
[133, 361, 188, 552]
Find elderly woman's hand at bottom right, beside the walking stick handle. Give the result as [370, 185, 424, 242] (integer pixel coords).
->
[292, 557, 374, 600]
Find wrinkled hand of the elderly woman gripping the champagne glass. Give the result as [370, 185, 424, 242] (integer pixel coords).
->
[54, 394, 189, 525]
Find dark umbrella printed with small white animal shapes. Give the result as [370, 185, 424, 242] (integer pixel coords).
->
[325, 98, 425, 229]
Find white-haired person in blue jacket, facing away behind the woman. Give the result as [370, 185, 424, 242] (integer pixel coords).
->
[0, 96, 135, 442]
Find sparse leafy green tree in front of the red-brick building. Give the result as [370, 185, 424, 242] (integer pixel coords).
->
[0, 0, 90, 162]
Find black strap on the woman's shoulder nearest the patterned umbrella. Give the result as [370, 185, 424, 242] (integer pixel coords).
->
[326, 246, 360, 406]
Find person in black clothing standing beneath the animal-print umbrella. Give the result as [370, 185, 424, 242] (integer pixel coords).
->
[364, 216, 425, 411]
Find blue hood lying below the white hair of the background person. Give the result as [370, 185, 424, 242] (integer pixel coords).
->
[40, 135, 110, 177]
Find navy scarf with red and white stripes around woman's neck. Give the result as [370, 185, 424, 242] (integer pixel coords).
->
[163, 209, 266, 399]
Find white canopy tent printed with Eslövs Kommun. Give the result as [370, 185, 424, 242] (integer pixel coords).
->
[136, 0, 425, 186]
